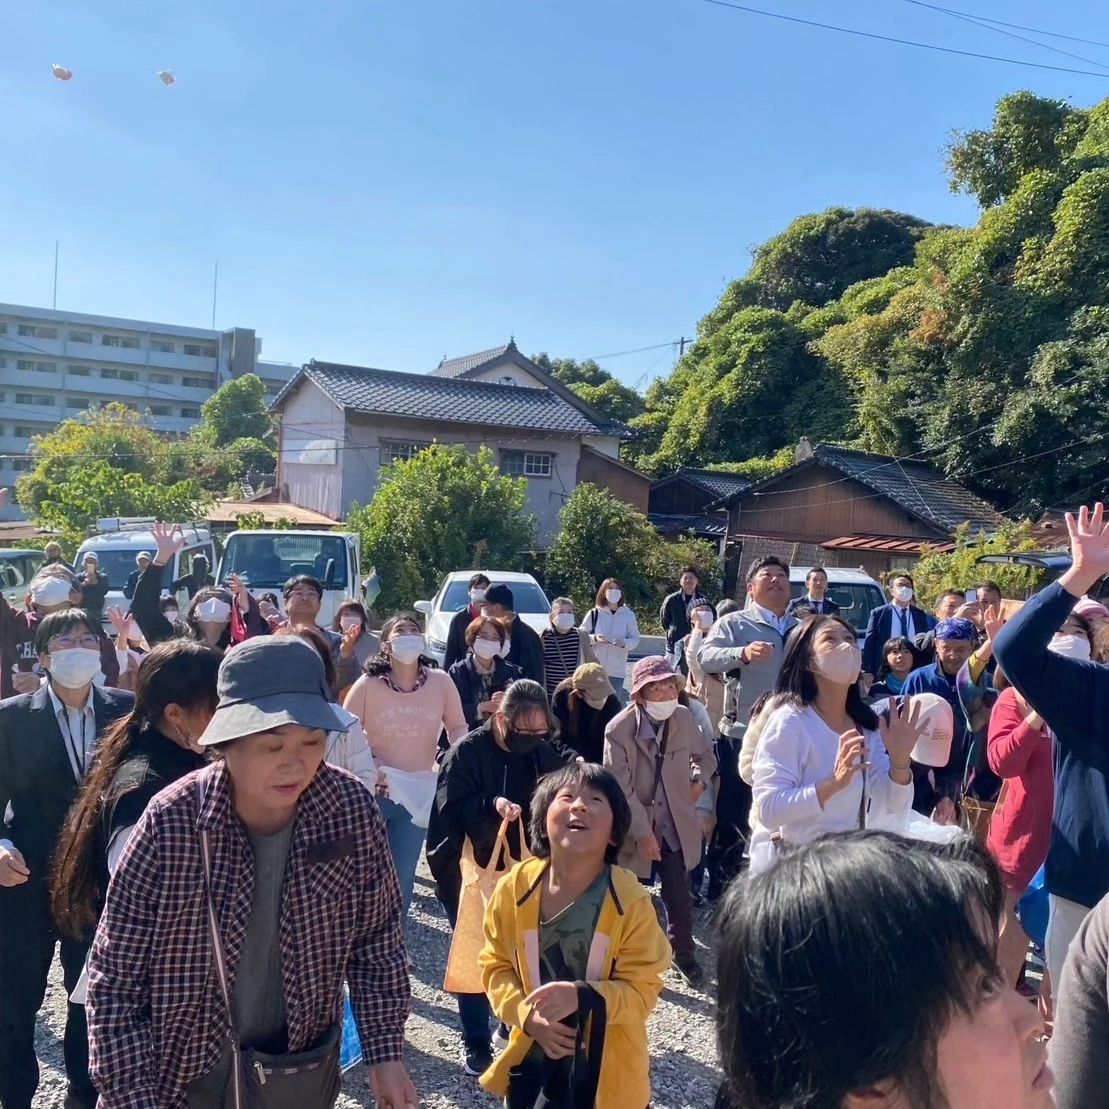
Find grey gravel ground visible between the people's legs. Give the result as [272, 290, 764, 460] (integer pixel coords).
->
[34, 866, 720, 1109]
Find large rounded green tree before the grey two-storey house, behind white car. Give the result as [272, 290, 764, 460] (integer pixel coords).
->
[347, 444, 535, 610]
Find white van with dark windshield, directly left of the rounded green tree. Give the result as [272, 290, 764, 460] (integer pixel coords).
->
[216, 528, 366, 628]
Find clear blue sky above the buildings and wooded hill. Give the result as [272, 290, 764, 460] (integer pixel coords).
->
[0, 0, 1109, 390]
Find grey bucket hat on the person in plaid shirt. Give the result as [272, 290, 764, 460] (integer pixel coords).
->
[197, 635, 343, 747]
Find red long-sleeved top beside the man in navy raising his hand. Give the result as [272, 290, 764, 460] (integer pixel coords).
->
[986, 686, 1055, 893]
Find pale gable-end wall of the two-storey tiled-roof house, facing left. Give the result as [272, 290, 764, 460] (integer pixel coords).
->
[277, 381, 349, 519]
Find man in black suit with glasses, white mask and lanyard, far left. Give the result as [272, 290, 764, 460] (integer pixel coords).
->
[0, 609, 134, 1109]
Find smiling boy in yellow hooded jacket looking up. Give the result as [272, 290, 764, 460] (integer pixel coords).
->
[480, 763, 671, 1109]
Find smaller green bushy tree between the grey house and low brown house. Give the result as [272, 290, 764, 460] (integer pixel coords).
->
[547, 484, 721, 630]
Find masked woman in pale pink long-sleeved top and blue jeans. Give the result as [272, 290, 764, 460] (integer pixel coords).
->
[344, 612, 467, 913]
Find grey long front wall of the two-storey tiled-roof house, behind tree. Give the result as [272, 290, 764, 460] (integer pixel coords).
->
[341, 414, 581, 546]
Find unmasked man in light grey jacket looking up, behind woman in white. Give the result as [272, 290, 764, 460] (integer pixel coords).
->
[698, 555, 797, 899]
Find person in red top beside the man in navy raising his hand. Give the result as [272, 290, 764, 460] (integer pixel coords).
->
[986, 670, 1055, 985]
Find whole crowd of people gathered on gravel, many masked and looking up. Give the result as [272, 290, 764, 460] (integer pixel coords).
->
[0, 506, 1109, 1109]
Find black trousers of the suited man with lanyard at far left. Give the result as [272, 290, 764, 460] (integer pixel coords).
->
[0, 878, 96, 1109]
